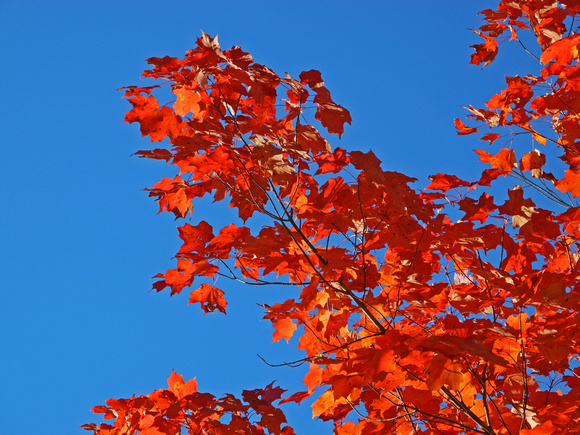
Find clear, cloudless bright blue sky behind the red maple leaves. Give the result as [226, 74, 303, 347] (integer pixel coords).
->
[0, 0, 525, 435]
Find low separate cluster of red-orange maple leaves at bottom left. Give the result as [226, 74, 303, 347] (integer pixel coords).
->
[83, 372, 294, 435]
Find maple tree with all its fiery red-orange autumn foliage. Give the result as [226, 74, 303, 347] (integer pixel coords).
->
[84, 0, 580, 435]
